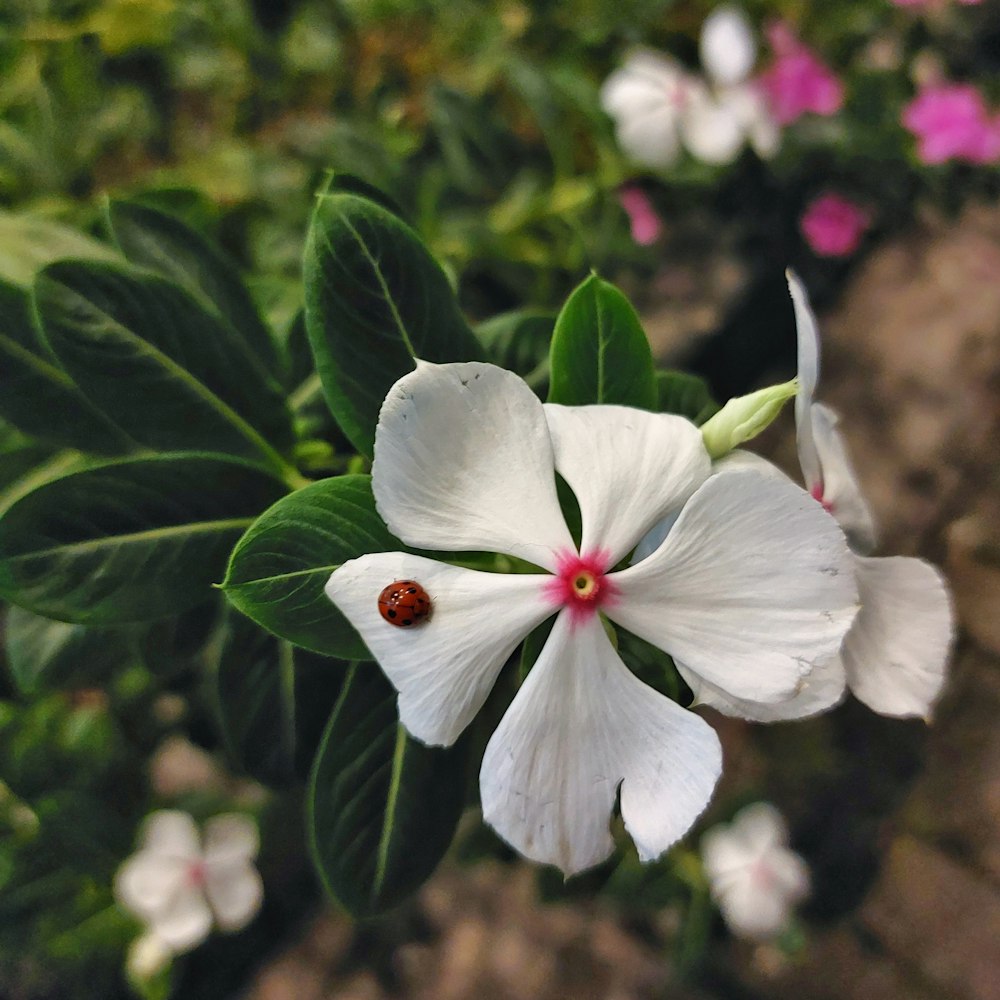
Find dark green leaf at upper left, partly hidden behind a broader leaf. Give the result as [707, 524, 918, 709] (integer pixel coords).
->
[107, 201, 279, 373]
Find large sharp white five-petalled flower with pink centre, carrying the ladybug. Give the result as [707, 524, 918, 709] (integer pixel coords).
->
[326, 362, 856, 874]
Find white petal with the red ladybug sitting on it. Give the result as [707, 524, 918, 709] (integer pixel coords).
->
[326, 552, 555, 746]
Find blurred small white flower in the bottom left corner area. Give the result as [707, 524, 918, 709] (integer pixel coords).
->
[115, 809, 264, 953]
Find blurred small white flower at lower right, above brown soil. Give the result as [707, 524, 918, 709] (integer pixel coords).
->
[701, 802, 809, 940]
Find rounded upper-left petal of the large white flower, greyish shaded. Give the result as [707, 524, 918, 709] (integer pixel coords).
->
[372, 361, 573, 582]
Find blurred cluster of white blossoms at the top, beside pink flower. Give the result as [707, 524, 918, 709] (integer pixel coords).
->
[601, 6, 780, 169]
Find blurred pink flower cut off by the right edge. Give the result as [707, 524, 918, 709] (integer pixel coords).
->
[902, 83, 1000, 164]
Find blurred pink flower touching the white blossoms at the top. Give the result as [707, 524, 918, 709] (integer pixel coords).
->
[759, 21, 844, 125]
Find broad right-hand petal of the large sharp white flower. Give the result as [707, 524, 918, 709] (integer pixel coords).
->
[607, 471, 857, 702]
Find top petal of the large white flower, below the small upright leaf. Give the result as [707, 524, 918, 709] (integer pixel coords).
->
[545, 403, 711, 566]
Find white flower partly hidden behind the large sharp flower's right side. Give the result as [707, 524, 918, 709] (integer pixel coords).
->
[668, 274, 954, 722]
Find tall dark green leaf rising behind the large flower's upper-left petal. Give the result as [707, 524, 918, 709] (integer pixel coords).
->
[304, 192, 482, 457]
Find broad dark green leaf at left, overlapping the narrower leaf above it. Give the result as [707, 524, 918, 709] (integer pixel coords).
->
[35, 261, 292, 470]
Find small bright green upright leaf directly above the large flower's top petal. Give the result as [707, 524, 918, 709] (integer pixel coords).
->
[549, 274, 657, 410]
